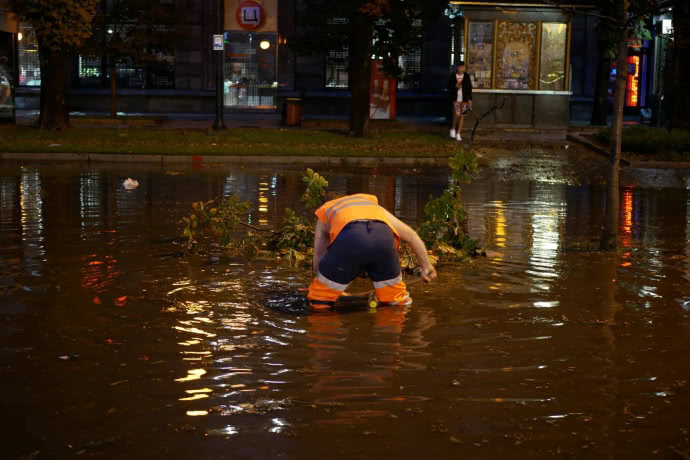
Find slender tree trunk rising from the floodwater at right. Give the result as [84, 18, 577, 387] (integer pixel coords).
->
[601, 0, 629, 250]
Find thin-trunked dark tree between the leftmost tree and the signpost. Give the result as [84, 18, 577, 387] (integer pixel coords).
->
[81, 0, 180, 118]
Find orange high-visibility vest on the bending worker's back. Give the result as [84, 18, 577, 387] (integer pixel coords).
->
[314, 193, 400, 247]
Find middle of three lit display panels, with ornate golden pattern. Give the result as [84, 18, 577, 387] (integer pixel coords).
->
[496, 21, 537, 89]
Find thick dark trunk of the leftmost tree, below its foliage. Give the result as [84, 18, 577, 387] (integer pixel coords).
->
[38, 44, 71, 131]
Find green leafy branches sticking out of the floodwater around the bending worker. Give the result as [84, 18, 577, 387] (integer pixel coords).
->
[182, 160, 478, 270]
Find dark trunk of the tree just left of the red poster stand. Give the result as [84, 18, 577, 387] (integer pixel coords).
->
[349, 14, 373, 137]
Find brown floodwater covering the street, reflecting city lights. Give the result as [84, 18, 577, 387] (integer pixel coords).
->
[0, 154, 690, 459]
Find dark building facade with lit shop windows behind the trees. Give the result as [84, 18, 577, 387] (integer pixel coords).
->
[15, 0, 598, 127]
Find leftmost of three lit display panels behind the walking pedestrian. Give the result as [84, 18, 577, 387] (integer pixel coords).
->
[466, 22, 494, 88]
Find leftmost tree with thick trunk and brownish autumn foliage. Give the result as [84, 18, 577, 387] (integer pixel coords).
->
[10, 0, 100, 130]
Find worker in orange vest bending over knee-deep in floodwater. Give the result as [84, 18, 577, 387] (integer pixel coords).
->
[308, 193, 436, 311]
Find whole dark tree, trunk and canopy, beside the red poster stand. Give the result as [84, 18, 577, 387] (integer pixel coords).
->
[296, 0, 447, 136]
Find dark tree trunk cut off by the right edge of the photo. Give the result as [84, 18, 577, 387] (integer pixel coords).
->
[670, 0, 690, 130]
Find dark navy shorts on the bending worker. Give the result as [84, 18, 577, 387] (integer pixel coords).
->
[319, 220, 400, 285]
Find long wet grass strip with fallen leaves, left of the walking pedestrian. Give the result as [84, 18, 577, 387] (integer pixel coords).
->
[0, 126, 460, 158]
